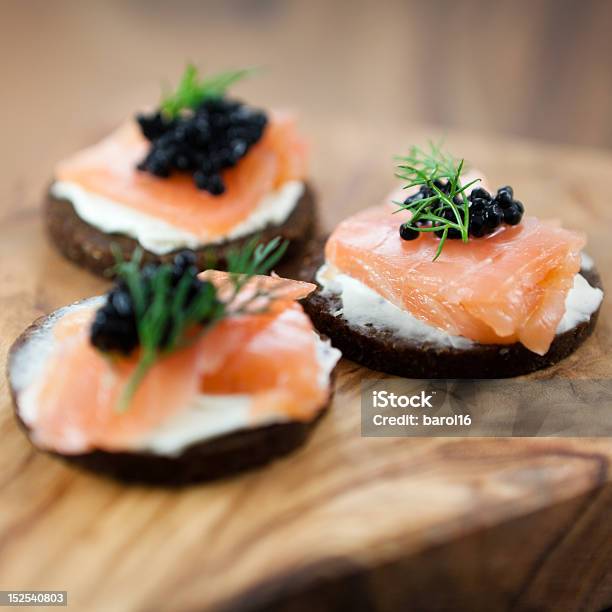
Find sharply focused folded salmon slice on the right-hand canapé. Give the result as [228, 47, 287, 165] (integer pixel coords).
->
[325, 204, 586, 355]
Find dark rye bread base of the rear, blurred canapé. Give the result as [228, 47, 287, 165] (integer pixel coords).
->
[44, 185, 317, 275]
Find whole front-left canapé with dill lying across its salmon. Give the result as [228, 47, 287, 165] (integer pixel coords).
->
[8, 241, 340, 484]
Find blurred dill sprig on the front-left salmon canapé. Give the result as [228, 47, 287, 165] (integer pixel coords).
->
[110, 237, 288, 412]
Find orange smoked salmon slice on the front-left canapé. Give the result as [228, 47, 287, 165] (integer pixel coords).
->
[24, 272, 329, 454]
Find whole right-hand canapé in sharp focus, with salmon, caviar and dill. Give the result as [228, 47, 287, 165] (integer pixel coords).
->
[305, 145, 603, 378]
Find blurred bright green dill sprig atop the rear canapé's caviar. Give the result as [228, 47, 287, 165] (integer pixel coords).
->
[160, 63, 255, 119]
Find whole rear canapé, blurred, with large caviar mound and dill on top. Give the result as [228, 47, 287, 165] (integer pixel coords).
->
[45, 65, 315, 274]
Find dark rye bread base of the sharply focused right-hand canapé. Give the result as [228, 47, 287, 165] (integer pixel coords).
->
[298, 243, 602, 379]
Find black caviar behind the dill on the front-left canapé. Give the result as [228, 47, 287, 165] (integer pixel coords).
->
[90, 251, 216, 355]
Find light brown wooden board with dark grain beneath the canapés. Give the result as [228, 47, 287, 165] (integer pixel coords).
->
[0, 123, 612, 611]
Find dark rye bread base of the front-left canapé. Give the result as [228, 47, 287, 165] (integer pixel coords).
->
[7, 308, 331, 486]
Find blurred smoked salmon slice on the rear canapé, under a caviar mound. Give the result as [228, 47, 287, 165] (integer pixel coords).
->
[55, 112, 308, 239]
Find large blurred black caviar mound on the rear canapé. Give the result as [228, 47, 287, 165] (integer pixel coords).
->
[137, 98, 268, 195]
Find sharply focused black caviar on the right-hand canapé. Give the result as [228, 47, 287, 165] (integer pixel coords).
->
[400, 180, 525, 240]
